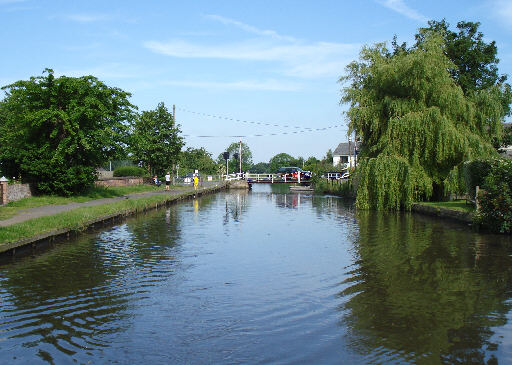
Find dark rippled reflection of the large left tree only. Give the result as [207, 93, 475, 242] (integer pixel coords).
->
[0, 232, 134, 363]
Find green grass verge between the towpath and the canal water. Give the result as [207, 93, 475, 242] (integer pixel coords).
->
[0, 186, 217, 248]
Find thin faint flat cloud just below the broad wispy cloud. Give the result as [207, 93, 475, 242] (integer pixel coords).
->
[162, 80, 302, 91]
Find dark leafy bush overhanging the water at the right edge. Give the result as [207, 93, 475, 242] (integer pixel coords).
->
[476, 160, 512, 233]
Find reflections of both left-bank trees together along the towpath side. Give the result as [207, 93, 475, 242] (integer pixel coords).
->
[0, 202, 188, 364]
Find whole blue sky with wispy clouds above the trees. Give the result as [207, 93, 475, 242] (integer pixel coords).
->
[0, 0, 512, 162]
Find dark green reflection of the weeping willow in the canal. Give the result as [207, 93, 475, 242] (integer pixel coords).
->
[340, 212, 512, 364]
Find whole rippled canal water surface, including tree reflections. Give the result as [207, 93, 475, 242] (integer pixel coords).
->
[0, 185, 512, 364]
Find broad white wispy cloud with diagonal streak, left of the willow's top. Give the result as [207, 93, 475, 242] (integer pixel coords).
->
[144, 15, 361, 79]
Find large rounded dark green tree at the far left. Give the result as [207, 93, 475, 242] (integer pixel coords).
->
[0, 69, 135, 195]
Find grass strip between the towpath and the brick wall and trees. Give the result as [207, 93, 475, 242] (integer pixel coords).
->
[0, 185, 171, 220]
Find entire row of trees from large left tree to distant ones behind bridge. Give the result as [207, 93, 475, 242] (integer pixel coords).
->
[0, 69, 338, 195]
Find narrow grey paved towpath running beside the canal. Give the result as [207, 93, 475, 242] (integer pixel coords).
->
[0, 183, 216, 227]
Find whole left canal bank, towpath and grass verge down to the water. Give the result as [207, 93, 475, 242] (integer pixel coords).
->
[0, 182, 228, 256]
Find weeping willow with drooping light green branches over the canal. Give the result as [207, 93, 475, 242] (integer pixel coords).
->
[340, 33, 505, 210]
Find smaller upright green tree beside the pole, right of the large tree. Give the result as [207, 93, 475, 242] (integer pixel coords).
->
[130, 103, 184, 176]
